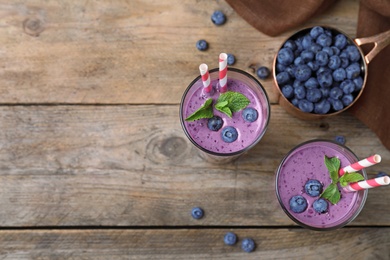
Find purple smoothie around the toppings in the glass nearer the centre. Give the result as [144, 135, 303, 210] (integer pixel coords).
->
[181, 68, 270, 156]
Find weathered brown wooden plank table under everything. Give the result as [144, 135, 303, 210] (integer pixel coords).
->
[0, 0, 390, 259]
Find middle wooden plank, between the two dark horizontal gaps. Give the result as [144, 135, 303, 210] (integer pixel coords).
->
[0, 105, 390, 227]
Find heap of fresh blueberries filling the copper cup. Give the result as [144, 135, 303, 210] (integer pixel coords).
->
[275, 26, 364, 114]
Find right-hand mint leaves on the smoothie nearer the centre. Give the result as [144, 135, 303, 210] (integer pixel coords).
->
[215, 91, 250, 117]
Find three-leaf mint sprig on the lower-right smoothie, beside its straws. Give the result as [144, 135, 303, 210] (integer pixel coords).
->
[320, 156, 364, 205]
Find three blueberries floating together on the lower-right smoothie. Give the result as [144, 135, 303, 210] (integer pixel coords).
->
[290, 180, 328, 214]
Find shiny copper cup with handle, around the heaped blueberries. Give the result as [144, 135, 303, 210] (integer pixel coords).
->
[273, 25, 390, 120]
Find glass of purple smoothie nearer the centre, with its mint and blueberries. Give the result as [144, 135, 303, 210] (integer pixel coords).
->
[180, 68, 270, 163]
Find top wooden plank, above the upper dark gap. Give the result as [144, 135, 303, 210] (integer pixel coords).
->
[0, 0, 358, 104]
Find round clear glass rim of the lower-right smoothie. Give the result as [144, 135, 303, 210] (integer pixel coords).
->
[275, 139, 368, 231]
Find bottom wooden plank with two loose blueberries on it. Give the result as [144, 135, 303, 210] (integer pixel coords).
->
[0, 228, 390, 260]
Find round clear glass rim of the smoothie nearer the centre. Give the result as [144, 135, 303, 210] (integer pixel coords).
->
[179, 67, 271, 157]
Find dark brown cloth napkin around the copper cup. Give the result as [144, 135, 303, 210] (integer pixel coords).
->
[226, 0, 390, 150]
